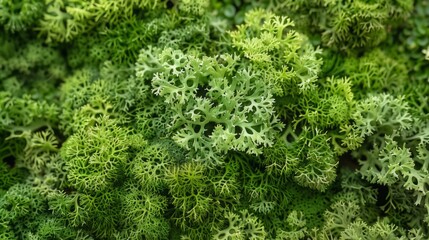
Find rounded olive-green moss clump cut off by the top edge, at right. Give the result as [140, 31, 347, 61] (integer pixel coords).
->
[267, 0, 414, 52]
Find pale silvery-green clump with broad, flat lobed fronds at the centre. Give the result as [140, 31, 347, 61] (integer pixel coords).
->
[136, 48, 281, 162]
